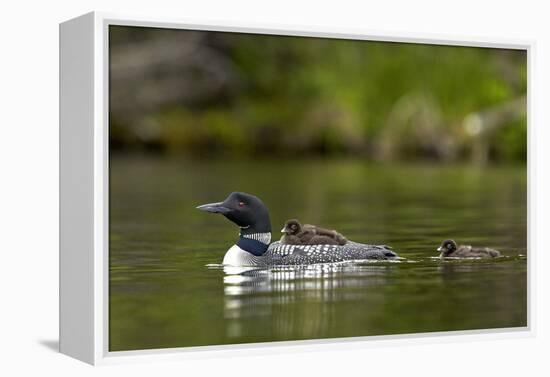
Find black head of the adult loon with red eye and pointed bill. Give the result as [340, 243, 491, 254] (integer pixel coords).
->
[197, 192, 271, 234]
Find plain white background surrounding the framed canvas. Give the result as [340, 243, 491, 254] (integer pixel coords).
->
[0, 0, 550, 377]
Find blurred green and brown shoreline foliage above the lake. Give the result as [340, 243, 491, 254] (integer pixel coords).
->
[109, 26, 527, 163]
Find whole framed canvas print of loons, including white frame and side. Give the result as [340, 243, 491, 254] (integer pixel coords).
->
[60, 13, 532, 364]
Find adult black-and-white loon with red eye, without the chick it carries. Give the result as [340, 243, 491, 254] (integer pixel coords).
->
[197, 192, 399, 266]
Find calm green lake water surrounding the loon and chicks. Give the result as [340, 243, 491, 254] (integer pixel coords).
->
[109, 156, 527, 351]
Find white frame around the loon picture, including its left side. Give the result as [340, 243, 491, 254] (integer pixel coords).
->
[60, 12, 535, 364]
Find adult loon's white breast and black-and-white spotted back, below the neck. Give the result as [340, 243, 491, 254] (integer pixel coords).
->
[224, 241, 399, 266]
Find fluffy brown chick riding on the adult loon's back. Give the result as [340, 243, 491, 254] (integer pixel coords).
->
[281, 219, 348, 245]
